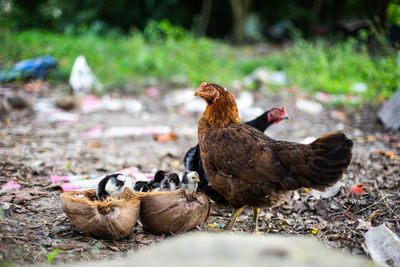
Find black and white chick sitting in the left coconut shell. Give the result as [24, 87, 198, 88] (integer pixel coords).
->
[96, 173, 129, 201]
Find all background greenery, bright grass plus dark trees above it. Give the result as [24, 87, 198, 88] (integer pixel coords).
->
[0, 0, 400, 100]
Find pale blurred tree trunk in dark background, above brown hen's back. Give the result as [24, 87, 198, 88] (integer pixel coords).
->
[231, 0, 251, 43]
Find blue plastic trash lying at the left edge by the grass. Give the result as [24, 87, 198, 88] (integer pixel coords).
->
[0, 55, 57, 82]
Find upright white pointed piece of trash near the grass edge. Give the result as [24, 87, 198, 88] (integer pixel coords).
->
[69, 55, 103, 94]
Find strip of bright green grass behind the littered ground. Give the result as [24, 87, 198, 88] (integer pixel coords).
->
[0, 22, 397, 101]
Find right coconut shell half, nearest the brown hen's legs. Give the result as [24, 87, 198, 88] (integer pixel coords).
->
[135, 189, 210, 234]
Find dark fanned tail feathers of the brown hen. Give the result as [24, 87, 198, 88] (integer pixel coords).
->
[282, 131, 353, 190]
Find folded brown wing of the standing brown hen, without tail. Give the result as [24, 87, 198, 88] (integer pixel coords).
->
[201, 124, 286, 182]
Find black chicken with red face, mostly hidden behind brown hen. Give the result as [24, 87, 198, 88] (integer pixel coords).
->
[183, 107, 289, 203]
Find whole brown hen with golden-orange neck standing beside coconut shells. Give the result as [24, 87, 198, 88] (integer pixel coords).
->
[195, 83, 353, 231]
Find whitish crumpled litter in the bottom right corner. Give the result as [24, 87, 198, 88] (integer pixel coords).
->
[364, 224, 400, 266]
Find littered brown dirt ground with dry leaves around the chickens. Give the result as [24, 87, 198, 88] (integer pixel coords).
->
[0, 85, 400, 264]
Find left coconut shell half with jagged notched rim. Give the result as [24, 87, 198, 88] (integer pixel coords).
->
[60, 189, 140, 240]
